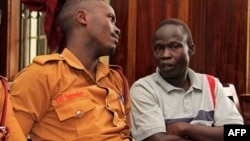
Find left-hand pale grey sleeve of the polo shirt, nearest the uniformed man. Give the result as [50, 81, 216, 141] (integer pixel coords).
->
[130, 81, 166, 141]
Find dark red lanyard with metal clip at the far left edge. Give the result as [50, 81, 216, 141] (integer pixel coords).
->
[0, 76, 9, 141]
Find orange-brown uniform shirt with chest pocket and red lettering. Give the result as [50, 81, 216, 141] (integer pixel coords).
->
[10, 48, 131, 141]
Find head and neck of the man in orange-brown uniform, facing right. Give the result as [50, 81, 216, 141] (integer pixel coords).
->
[61, 0, 120, 79]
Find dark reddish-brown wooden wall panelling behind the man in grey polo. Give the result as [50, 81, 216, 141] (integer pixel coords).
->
[111, 0, 248, 93]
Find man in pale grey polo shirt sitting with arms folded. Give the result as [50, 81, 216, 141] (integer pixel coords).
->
[130, 19, 243, 141]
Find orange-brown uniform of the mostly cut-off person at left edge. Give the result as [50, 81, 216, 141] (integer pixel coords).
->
[0, 77, 26, 141]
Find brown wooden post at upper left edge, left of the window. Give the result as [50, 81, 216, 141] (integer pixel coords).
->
[0, 0, 21, 81]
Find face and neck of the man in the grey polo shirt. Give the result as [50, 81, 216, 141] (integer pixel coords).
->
[154, 25, 195, 90]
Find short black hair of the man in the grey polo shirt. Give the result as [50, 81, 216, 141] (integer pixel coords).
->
[153, 18, 193, 46]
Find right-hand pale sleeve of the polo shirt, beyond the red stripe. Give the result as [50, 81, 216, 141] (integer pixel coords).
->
[214, 79, 243, 126]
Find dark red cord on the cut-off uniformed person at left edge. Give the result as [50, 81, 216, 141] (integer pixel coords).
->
[0, 77, 9, 141]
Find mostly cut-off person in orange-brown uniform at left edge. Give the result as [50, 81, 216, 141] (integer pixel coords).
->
[0, 76, 26, 141]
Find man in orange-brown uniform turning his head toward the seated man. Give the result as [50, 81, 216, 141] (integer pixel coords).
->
[10, 0, 131, 141]
